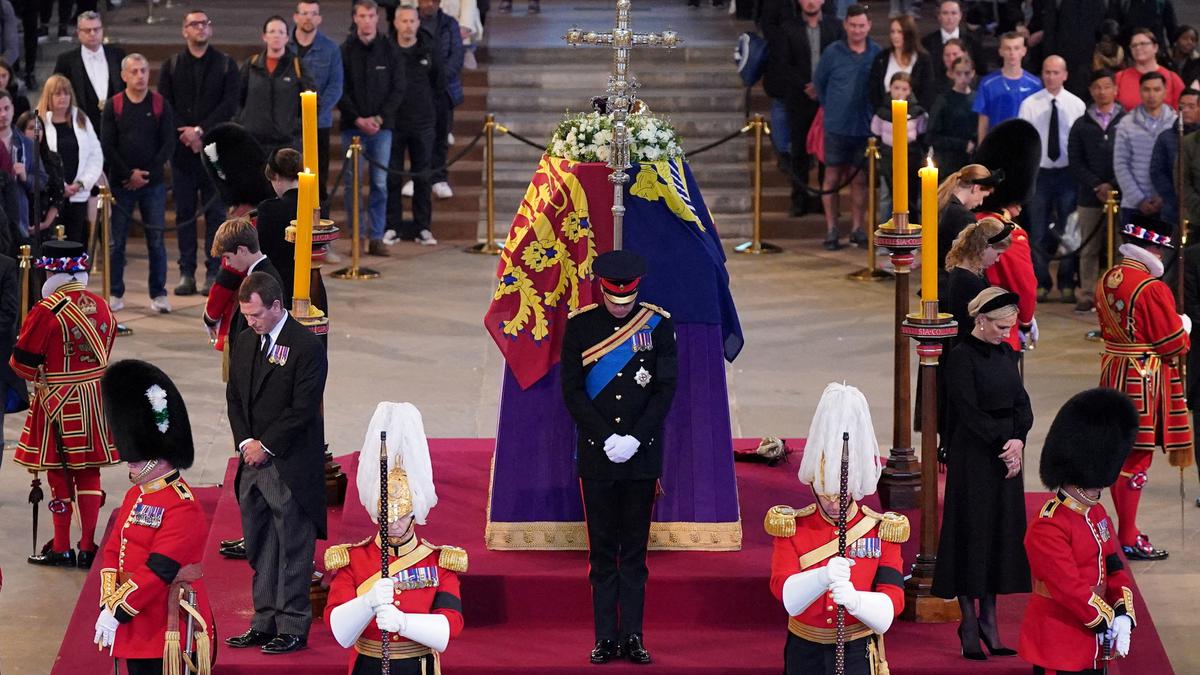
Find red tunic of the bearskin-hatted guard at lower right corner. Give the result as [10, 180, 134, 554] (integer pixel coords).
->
[1018, 491, 1138, 671]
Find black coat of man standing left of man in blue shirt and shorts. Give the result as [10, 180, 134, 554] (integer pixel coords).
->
[762, 12, 846, 100]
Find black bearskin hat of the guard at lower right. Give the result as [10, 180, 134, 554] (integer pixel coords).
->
[1039, 387, 1138, 489]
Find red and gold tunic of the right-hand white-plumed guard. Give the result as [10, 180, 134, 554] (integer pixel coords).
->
[766, 502, 910, 674]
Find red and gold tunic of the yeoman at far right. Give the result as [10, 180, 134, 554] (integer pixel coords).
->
[1096, 257, 1192, 454]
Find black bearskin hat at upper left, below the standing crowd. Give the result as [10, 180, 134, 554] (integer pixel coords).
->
[200, 123, 276, 207]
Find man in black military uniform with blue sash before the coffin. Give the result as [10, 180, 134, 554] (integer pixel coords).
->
[562, 251, 678, 663]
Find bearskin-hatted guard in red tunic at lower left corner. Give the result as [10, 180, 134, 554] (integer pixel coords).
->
[95, 360, 216, 675]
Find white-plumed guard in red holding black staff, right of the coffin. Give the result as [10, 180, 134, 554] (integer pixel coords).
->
[766, 382, 910, 675]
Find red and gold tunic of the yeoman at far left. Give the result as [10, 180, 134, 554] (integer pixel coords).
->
[8, 281, 119, 471]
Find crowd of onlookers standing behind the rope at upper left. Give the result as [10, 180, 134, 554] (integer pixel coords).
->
[0, 0, 487, 313]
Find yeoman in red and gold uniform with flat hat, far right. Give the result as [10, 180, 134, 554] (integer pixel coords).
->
[1096, 214, 1193, 560]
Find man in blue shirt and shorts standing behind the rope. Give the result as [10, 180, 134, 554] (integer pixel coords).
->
[796, 4, 880, 251]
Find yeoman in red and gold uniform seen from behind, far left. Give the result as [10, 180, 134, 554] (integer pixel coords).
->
[8, 240, 120, 568]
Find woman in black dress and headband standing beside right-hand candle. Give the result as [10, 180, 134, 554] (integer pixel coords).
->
[932, 286, 1033, 661]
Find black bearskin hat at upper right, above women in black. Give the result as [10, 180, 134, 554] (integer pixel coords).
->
[974, 118, 1042, 211]
